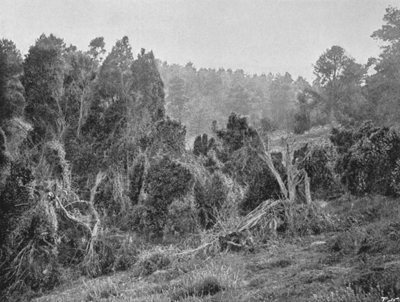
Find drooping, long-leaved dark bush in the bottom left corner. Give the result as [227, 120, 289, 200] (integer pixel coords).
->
[1, 198, 60, 292]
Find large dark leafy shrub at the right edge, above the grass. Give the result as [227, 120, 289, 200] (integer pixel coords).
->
[331, 122, 400, 196]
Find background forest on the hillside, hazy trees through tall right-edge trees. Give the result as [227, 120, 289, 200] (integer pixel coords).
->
[158, 8, 400, 136]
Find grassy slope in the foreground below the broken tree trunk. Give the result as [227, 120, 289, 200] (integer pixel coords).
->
[32, 197, 400, 302]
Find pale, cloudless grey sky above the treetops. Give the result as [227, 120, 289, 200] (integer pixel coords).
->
[0, 0, 400, 81]
